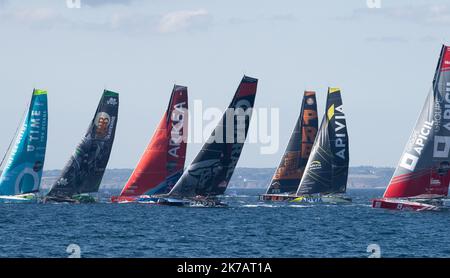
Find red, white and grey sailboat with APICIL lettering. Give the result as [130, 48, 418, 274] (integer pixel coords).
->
[372, 45, 450, 211]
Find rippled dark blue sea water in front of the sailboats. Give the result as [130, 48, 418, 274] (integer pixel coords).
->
[0, 189, 450, 258]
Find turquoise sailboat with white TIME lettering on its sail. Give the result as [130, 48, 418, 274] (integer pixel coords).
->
[0, 89, 48, 203]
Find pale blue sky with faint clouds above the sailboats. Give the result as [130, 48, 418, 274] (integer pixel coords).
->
[0, 0, 450, 169]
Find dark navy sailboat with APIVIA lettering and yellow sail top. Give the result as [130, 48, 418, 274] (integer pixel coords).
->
[292, 88, 351, 203]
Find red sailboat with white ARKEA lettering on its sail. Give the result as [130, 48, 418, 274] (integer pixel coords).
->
[111, 85, 188, 203]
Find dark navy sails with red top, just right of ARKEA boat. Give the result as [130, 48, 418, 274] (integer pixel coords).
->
[168, 76, 258, 198]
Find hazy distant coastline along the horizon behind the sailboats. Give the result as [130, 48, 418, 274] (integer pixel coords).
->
[42, 166, 394, 191]
